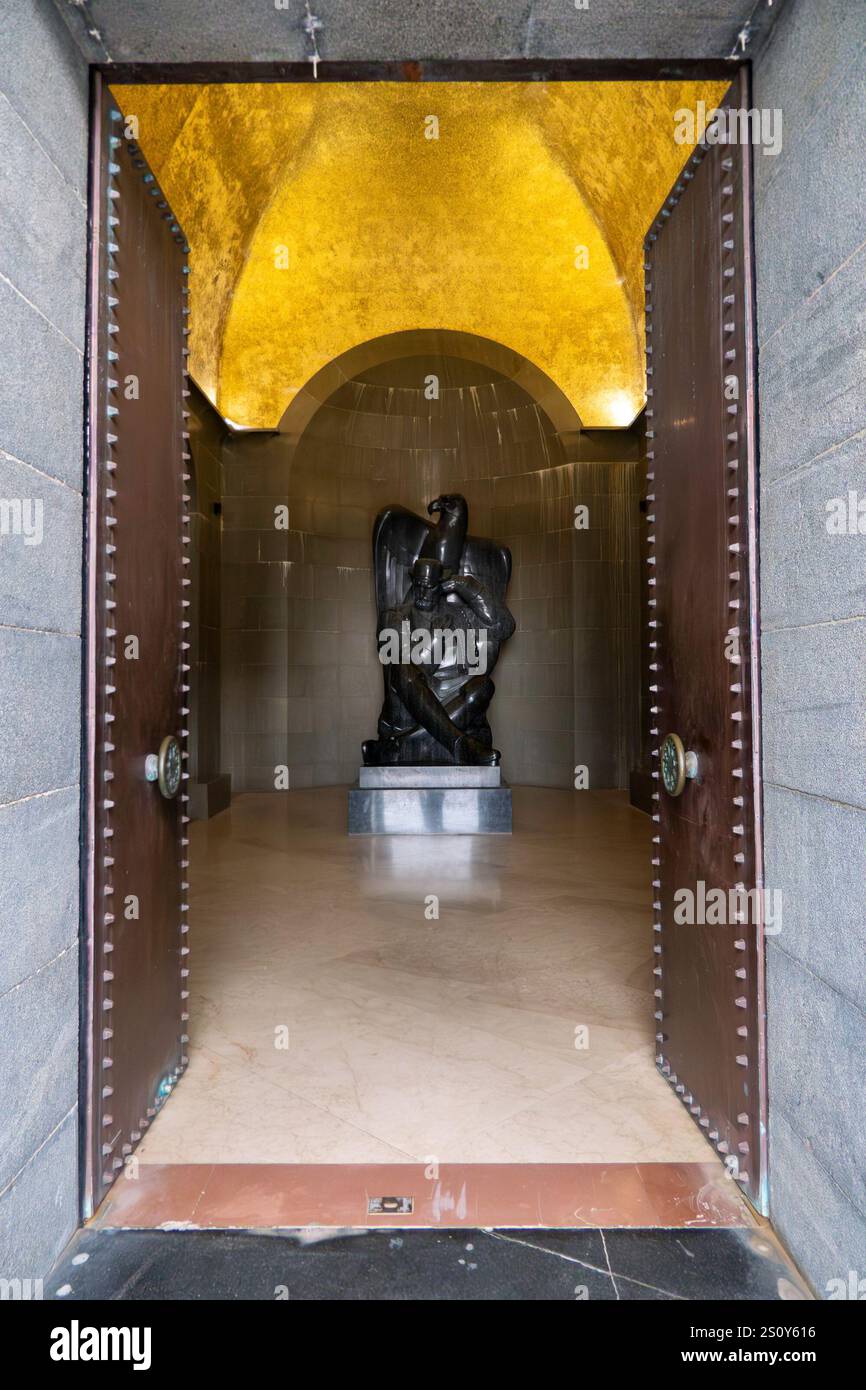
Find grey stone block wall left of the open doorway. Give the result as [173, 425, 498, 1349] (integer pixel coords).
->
[0, 4, 88, 1279]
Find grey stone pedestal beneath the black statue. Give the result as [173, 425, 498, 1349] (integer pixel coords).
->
[349, 766, 512, 835]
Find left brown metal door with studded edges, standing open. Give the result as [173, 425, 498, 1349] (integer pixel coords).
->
[83, 79, 189, 1215]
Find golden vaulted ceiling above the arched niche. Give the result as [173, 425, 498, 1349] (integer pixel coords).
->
[113, 82, 727, 428]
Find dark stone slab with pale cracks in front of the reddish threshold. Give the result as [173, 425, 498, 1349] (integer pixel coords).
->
[44, 1230, 811, 1301]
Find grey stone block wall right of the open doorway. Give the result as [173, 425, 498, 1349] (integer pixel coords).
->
[755, 0, 866, 1294]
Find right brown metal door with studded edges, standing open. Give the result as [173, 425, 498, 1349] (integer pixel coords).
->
[645, 72, 766, 1211]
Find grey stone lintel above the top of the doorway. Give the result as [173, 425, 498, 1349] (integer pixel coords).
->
[56, 0, 783, 63]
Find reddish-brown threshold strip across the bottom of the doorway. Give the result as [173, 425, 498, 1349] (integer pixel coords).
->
[90, 1162, 758, 1230]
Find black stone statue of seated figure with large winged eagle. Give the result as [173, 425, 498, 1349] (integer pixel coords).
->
[363, 492, 514, 766]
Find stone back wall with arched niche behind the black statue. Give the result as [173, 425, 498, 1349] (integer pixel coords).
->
[218, 329, 639, 792]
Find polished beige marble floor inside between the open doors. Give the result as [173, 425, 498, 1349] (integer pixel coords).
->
[138, 787, 717, 1165]
